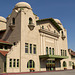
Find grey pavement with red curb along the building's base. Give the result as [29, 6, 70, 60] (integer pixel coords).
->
[0, 70, 75, 75]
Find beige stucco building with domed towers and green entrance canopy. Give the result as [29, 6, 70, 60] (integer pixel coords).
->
[0, 2, 75, 73]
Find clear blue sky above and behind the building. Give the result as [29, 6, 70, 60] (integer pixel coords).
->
[0, 0, 75, 51]
